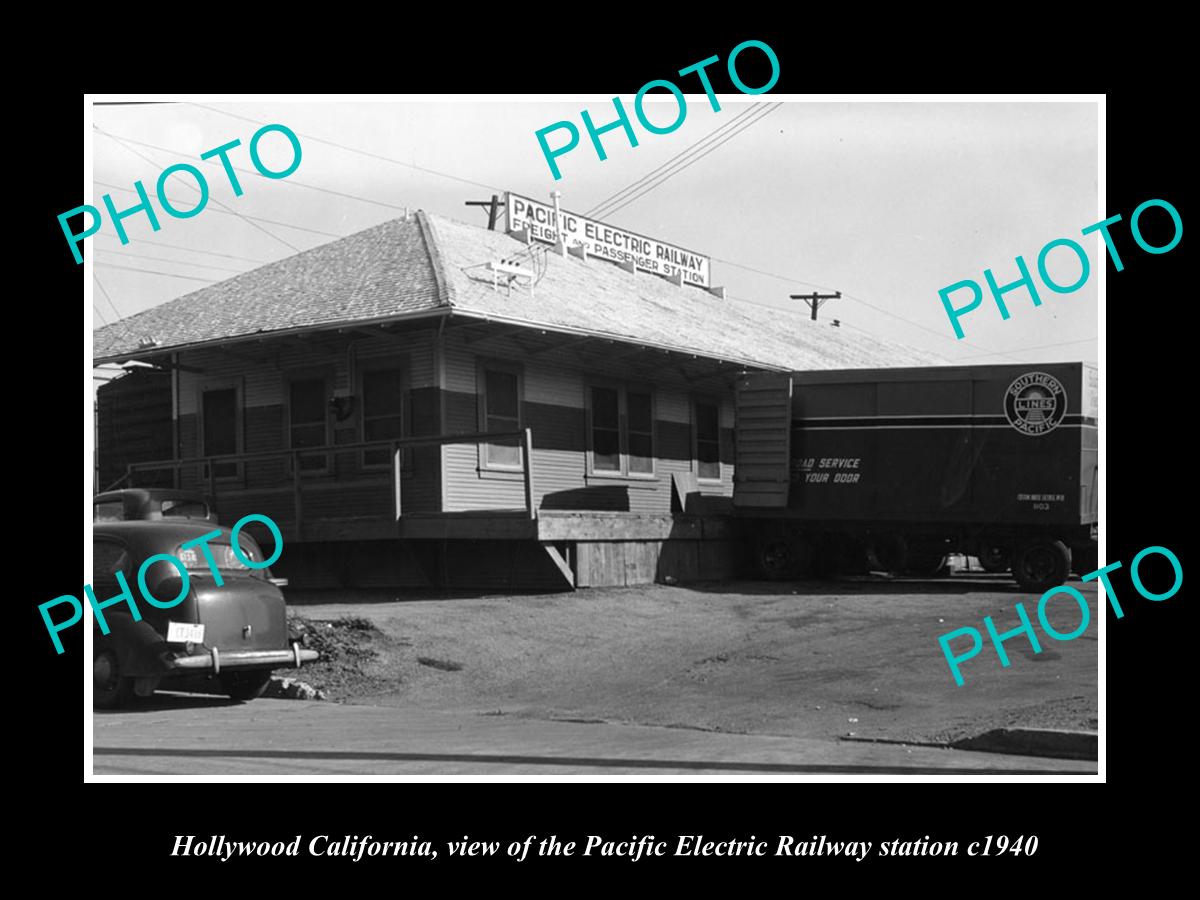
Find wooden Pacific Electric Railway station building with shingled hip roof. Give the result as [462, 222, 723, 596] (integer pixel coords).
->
[95, 196, 929, 589]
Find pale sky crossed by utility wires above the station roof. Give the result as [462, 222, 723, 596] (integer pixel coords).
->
[88, 94, 1099, 362]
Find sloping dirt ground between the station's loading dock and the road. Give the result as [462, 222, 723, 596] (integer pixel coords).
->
[281, 575, 1097, 743]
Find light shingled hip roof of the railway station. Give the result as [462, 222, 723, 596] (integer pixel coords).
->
[94, 212, 943, 370]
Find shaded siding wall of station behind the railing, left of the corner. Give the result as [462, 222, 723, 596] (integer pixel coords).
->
[179, 330, 440, 526]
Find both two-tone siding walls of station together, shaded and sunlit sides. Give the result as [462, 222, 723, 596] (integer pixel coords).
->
[160, 329, 733, 538]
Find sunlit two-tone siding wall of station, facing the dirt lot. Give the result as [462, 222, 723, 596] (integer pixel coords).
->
[443, 331, 733, 514]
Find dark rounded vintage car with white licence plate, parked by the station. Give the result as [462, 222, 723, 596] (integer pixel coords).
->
[92, 518, 317, 709]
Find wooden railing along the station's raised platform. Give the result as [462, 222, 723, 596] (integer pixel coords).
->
[106, 428, 536, 528]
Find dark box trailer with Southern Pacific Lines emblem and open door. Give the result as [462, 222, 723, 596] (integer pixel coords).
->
[733, 362, 1099, 592]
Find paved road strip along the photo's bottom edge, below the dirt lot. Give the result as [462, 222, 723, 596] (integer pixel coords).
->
[94, 695, 1096, 775]
